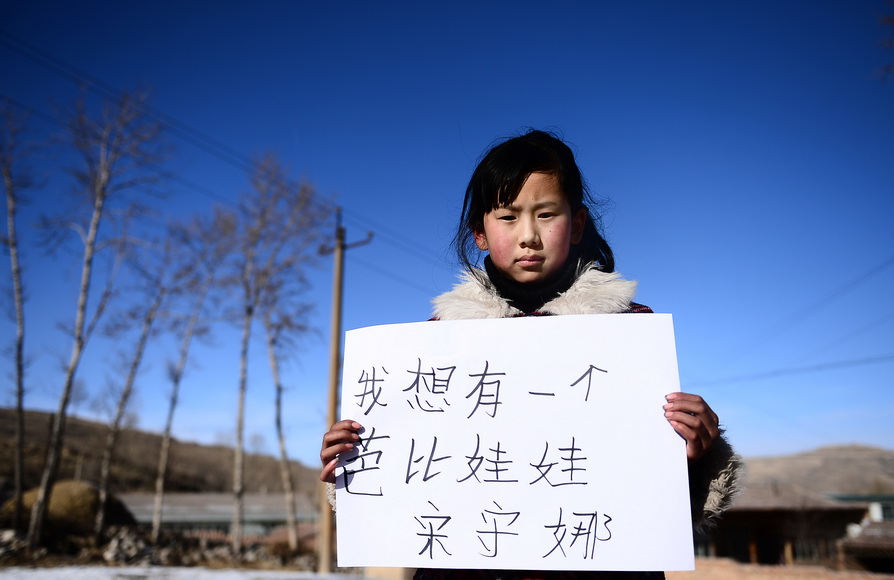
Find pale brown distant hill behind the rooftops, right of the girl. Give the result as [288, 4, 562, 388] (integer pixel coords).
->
[745, 445, 894, 494]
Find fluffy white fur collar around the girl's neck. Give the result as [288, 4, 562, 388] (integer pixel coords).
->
[432, 267, 636, 320]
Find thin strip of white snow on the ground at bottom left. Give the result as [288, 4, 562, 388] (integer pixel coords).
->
[0, 566, 359, 580]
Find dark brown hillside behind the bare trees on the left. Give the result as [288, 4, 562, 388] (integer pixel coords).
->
[0, 409, 319, 496]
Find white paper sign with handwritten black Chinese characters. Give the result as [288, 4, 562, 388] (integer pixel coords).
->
[336, 314, 694, 570]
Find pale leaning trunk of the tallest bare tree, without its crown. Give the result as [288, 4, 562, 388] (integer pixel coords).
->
[28, 190, 108, 548]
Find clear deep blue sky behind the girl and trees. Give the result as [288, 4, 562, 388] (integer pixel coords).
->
[0, 0, 894, 465]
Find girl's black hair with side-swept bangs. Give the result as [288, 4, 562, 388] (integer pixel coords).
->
[453, 130, 615, 272]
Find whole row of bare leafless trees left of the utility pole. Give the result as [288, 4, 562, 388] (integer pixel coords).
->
[0, 92, 332, 552]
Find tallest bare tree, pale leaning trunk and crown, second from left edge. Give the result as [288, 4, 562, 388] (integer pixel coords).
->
[28, 94, 161, 546]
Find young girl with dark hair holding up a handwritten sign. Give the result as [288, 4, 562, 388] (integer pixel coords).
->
[320, 131, 741, 580]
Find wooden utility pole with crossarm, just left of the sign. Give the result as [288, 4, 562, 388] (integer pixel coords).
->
[318, 207, 373, 574]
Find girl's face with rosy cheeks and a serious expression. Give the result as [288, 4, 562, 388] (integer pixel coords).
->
[475, 173, 587, 283]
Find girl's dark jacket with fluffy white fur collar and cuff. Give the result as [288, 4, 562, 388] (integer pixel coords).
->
[432, 267, 743, 530]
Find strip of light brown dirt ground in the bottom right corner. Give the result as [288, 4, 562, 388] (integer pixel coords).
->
[666, 558, 894, 580]
